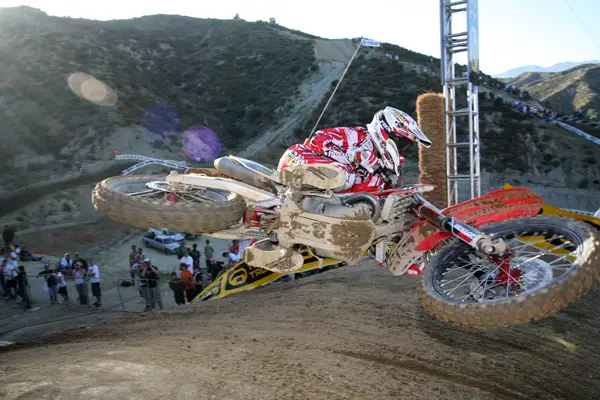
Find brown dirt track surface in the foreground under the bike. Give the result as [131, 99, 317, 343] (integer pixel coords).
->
[0, 264, 600, 400]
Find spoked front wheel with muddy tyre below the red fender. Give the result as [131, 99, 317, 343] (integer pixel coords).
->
[419, 216, 600, 328]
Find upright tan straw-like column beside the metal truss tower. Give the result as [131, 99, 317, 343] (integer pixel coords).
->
[417, 93, 448, 208]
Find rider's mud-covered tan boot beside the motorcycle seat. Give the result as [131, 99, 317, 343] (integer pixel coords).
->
[279, 164, 346, 192]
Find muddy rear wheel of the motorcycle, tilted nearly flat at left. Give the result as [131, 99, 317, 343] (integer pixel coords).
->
[92, 175, 246, 234]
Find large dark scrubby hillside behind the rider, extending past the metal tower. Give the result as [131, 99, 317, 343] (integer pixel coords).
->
[0, 7, 600, 238]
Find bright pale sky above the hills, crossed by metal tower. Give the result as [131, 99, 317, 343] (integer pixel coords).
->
[0, 0, 600, 74]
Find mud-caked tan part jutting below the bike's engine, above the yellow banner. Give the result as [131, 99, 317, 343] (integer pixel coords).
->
[244, 239, 304, 274]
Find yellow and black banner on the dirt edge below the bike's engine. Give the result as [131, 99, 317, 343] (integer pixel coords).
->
[193, 249, 341, 303]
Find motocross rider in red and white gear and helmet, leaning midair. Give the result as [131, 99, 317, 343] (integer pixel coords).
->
[278, 106, 431, 193]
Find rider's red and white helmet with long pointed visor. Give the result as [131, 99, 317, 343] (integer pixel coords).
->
[367, 106, 431, 175]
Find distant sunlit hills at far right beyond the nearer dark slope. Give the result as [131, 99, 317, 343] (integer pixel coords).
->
[506, 64, 600, 115]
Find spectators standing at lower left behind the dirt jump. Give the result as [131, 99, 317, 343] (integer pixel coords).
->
[0, 222, 318, 311]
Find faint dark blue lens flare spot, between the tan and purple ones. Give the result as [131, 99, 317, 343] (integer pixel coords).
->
[142, 102, 181, 142]
